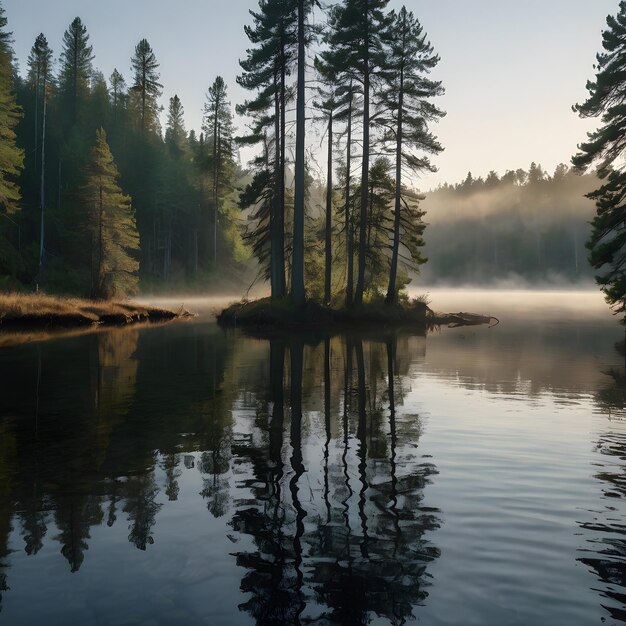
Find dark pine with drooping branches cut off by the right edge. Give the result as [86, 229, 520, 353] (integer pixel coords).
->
[572, 0, 626, 313]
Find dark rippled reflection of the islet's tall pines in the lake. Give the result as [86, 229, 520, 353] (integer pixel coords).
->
[232, 336, 440, 624]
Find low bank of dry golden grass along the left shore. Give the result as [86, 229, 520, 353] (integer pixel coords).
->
[0, 293, 189, 330]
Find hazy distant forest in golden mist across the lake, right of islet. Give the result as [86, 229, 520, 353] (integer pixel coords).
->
[418, 163, 598, 285]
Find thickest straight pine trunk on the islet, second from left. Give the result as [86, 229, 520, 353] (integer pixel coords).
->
[291, 0, 304, 306]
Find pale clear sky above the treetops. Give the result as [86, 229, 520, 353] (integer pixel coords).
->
[3, 0, 619, 188]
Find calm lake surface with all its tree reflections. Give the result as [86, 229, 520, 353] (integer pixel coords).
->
[0, 292, 626, 626]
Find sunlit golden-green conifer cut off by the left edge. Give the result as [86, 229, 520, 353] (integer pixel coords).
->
[0, 6, 24, 213]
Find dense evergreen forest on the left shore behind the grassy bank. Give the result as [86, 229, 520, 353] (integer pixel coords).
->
[0, 8, 246, 297]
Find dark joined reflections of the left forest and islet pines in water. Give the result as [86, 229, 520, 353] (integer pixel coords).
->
[0, 326, 439, 624]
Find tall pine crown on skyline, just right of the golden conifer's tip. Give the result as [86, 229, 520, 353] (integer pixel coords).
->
[131, 39, 163, 134]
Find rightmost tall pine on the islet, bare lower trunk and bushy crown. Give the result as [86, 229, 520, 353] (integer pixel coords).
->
[380, 6, 444, 304]
